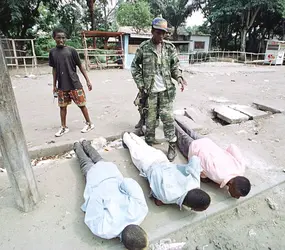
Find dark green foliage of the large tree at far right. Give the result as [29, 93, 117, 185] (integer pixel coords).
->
[201, 0, 284, 51]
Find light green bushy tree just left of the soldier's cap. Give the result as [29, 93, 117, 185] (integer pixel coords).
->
[117, 0, 153, 33]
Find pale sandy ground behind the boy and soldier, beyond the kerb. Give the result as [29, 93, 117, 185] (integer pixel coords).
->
[8, 63, 285, 147]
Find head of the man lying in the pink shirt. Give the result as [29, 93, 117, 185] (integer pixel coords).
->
[228, 176, 251, 199]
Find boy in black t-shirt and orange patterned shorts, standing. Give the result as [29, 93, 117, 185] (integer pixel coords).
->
[49, 29, 94, 137]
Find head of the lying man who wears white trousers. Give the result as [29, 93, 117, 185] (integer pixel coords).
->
[183, 188, 211, 212]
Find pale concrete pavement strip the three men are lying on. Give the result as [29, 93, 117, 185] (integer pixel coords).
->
[0, 119, 285, 250]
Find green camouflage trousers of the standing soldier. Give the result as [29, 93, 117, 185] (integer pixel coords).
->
[145, 91, 177, 144]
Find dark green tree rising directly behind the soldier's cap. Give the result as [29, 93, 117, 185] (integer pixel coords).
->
[151, 0, 200, 40]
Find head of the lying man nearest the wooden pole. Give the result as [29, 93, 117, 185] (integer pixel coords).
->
[122, 225, 148, 250]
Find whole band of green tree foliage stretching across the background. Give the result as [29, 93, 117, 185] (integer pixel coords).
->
[0, 0, 285, 55]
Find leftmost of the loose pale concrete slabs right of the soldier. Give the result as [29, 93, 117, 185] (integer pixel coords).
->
[214, 106, 249, 124]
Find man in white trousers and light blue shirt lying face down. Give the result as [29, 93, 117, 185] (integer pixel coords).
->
[123, 133, 211, 211]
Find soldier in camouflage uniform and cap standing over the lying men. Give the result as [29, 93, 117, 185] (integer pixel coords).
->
[131, 18, 186, 161]
